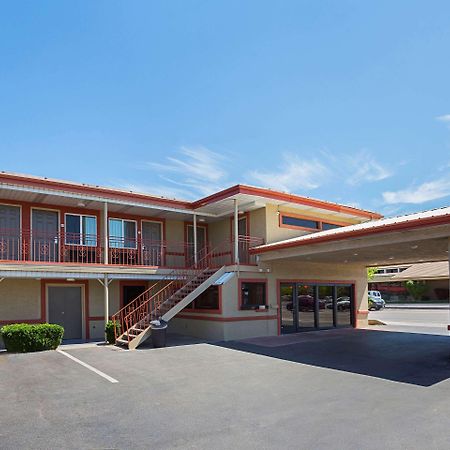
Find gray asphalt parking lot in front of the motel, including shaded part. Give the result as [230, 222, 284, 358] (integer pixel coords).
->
[0, 329, 450, 450]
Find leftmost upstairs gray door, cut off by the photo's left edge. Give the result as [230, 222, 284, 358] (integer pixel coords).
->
[0, 205, 20, 261]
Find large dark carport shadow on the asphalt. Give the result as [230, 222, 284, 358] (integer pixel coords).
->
[215, 329, 450, 386]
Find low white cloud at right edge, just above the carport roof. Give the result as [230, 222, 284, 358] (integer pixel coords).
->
[383, 177, 450, 204]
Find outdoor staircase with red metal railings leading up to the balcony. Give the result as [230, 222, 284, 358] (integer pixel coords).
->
[112, 244, 229, 350]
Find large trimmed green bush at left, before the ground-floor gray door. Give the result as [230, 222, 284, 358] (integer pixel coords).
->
[0, 323, 64, 353]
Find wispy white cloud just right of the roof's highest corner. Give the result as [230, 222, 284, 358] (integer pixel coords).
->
[249, 153, 330, 192]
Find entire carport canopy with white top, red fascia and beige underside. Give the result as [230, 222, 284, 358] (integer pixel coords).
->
[252, 207, 450, 267]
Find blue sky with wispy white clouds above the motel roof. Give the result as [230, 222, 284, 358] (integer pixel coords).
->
[0, 0, 450, 215]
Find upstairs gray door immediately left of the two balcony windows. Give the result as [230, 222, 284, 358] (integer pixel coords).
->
[31, 209, 59, 262]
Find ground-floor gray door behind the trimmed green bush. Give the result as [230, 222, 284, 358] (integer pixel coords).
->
[48, 286, 83, 339]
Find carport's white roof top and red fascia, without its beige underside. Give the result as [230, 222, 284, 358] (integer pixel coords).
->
[251, 206, 450, 253]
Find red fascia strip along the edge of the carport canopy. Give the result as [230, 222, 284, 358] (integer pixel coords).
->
[250, 215, 450, 253]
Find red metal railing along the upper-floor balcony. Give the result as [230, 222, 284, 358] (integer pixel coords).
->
[0, 230, 263, 268]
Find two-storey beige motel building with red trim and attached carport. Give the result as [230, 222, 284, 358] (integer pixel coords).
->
[0, 172, 450, 349]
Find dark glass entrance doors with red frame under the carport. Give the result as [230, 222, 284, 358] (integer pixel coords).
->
[280, 282, 354, 334]
